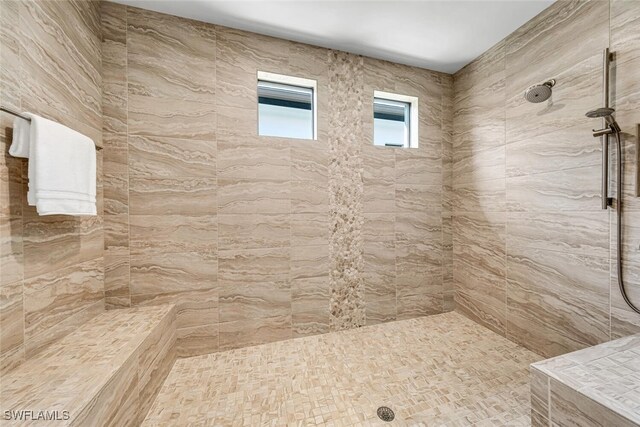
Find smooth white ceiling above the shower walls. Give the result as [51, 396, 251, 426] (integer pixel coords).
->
[116, 0, 553, 73]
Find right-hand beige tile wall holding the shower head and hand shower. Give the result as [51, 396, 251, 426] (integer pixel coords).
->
[453, 0, 640, 362]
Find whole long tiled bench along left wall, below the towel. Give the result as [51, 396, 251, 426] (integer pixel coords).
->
[0, 305, 176, 426]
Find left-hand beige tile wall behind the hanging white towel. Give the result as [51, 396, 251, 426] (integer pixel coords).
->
[0, 1, 104, 373]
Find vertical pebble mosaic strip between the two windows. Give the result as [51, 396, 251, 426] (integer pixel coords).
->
[329, 51, 366, 330]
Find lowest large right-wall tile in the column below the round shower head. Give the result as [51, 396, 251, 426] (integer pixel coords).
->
[507, 245, 609, 355]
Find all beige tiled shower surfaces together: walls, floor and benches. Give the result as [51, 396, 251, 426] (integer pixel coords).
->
[0, 0, 640, 426]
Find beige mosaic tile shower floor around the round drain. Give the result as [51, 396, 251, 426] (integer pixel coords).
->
[144, 312, 541, 426]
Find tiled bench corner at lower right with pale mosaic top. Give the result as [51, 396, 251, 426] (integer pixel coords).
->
[531, 334, 640, 427]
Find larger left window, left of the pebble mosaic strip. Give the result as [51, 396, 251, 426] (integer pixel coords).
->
[258, 71, 317, 139]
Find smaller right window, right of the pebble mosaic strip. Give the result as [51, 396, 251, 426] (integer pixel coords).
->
[373, 91, 418, 148]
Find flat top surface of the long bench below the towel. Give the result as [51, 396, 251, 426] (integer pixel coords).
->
[0, 304, 176, 425]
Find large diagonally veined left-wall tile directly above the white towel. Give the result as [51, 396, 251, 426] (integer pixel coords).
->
[19, 1, 102, 135]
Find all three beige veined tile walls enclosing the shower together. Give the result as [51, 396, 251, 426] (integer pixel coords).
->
[10, 0, 640, 369]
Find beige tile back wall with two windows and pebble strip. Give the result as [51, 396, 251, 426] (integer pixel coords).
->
[102, 3, 452, 355]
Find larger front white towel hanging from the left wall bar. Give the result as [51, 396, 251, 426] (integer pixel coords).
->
[27, 115, 96, 215]
